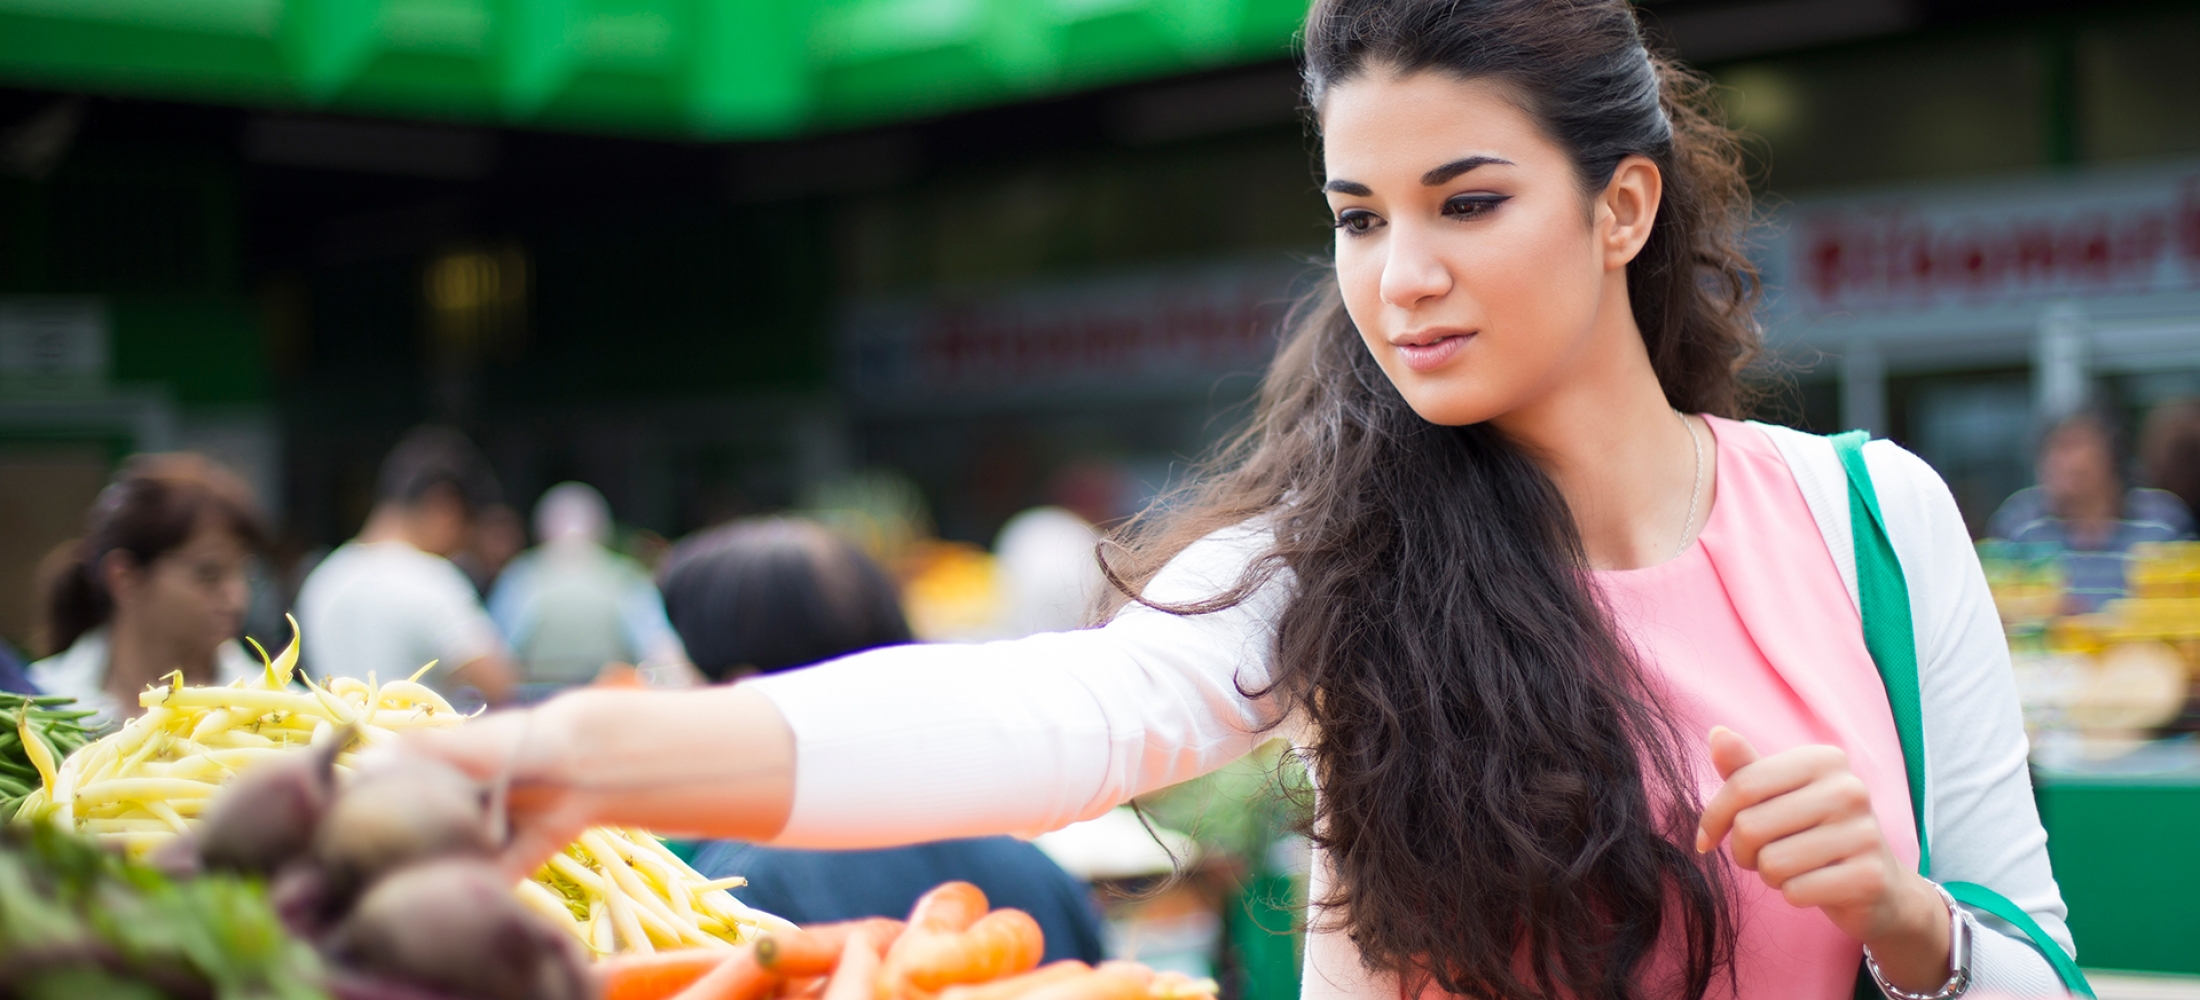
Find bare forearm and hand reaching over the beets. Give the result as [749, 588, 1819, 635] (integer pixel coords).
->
[407, 684, 794, 870]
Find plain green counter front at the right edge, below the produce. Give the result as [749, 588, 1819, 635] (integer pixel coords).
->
[2033, 743, 2200, 974]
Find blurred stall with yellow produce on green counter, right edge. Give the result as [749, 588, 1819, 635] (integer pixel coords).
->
[1980, 543, 2200, 974]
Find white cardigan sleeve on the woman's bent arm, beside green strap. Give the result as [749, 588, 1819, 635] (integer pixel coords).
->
[1863, 442, 2077, 996]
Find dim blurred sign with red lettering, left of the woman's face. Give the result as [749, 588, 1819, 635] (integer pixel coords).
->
[838, 264, 1305, 409]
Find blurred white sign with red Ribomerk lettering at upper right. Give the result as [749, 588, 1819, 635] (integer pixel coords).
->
[1764, 165, 2200, 316]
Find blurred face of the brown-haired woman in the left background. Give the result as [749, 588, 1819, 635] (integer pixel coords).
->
[110, 516, 251, 655]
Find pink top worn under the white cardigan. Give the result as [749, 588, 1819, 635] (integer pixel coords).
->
[1595, 418, 1916, 1000]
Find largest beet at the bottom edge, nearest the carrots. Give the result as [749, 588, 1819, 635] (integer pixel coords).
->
[323, 859, 596, 1000]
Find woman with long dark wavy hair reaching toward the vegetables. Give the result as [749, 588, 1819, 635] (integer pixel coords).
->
[422, 0, 2068, 1000]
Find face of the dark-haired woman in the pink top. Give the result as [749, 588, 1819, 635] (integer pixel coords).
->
[1320, 66, 1657, 426]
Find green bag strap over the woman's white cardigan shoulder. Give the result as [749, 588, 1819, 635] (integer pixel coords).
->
[1830, 431, 2094, 998]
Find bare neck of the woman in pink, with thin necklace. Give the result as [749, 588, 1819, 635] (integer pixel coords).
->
[1494, 305, 1716, 569]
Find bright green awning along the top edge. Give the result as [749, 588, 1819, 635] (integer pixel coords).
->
[0, 0, 1305, 138]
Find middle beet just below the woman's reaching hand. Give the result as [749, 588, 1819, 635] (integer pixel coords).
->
[312, 758, 497, 905]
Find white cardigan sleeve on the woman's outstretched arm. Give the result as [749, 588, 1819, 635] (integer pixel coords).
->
[750, 527, 1291, 848]
